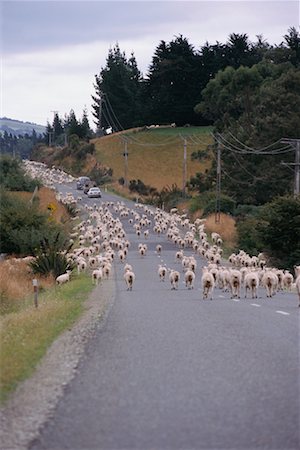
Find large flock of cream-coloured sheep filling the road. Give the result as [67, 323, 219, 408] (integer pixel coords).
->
[26, 162, 300, 306]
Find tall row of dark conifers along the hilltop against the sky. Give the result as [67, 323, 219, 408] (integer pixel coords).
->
[92, 27, 300, 131]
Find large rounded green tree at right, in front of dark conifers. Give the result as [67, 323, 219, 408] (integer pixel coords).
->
[196, 61, 300, 205]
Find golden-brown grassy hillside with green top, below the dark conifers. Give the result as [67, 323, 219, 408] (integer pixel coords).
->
[93, 127, 212, 190]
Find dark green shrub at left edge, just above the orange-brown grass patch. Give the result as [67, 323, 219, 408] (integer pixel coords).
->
[0, 155, 41, 192]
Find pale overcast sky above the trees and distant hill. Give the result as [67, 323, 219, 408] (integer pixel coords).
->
[0, 0, 299, 126]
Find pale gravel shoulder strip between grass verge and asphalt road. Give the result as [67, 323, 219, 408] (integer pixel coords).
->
[0, 272, 116, 450]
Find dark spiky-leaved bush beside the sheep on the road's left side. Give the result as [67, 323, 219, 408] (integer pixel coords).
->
[30, 232, 74, 278]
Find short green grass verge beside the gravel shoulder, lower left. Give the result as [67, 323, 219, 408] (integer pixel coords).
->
[0, 275, 94, 403]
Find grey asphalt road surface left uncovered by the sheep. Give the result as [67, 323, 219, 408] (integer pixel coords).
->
[30, 184, 300, 450]
